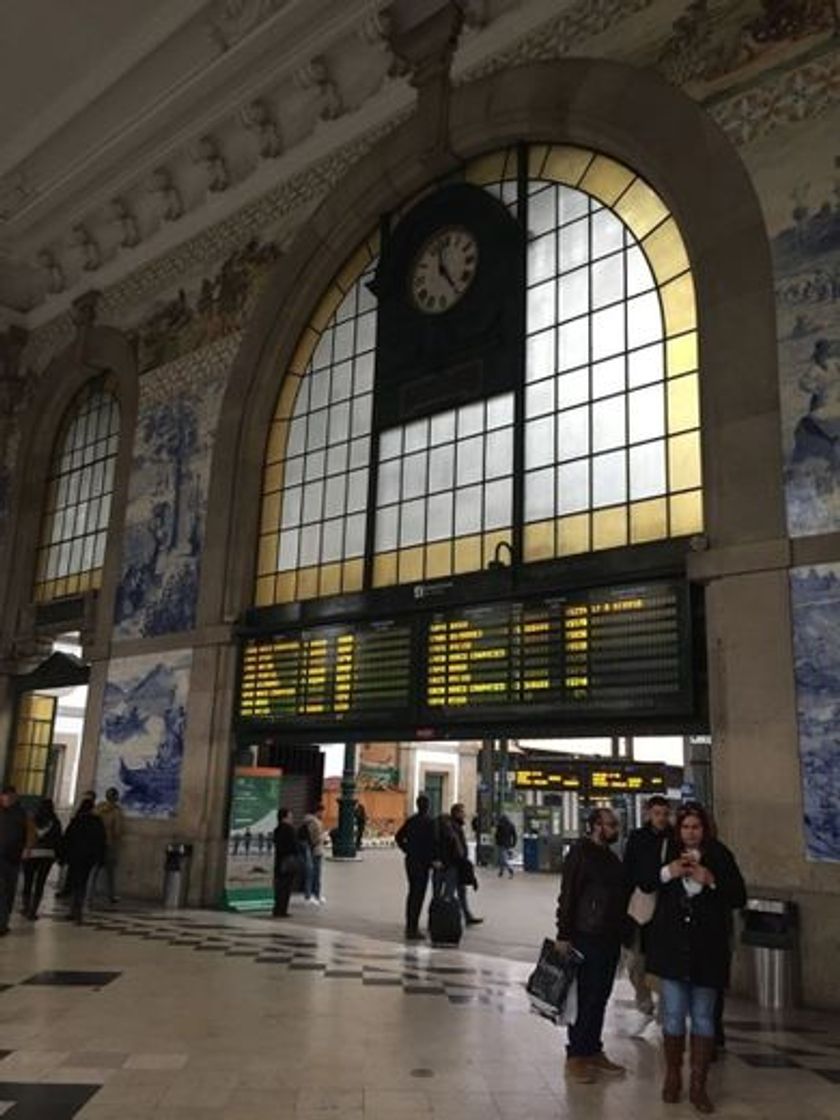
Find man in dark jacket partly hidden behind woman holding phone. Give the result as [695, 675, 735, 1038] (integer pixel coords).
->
[624, 794, 673, 1027]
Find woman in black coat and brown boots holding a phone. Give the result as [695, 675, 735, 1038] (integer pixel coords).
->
[646, 804, 747, 1112]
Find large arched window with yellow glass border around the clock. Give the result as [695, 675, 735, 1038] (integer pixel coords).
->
[256, 144, 703, 605]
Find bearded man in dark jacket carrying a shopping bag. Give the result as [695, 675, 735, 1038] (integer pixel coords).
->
[557, 809, 628, 1084]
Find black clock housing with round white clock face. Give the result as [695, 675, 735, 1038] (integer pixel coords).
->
[372, 183, 525, 430]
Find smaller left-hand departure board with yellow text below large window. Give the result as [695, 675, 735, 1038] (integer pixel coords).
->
[239, 622, 411, 722]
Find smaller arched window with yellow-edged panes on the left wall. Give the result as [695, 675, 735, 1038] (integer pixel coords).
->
[35, 375, 120, 603]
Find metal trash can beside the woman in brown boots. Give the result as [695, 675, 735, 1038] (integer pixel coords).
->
[741, 898, 799, 1011]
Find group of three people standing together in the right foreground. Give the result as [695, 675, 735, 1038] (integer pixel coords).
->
[557, 796, 746, 1112]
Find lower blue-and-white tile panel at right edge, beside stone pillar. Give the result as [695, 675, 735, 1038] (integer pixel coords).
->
[791, 564, 840, 860]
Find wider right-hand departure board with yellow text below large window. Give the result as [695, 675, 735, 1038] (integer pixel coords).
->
[427, 585, 685, 713]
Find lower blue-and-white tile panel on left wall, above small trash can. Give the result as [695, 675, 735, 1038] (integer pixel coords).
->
[96, 650, 193, 818]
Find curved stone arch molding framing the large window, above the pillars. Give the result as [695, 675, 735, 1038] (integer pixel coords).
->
[199, 58, 784, 624]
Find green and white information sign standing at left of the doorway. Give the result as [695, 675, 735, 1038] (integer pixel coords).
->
[225, 766, 282, 911]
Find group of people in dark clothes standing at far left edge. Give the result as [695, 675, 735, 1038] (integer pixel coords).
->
[0, 785, 123, 936]
